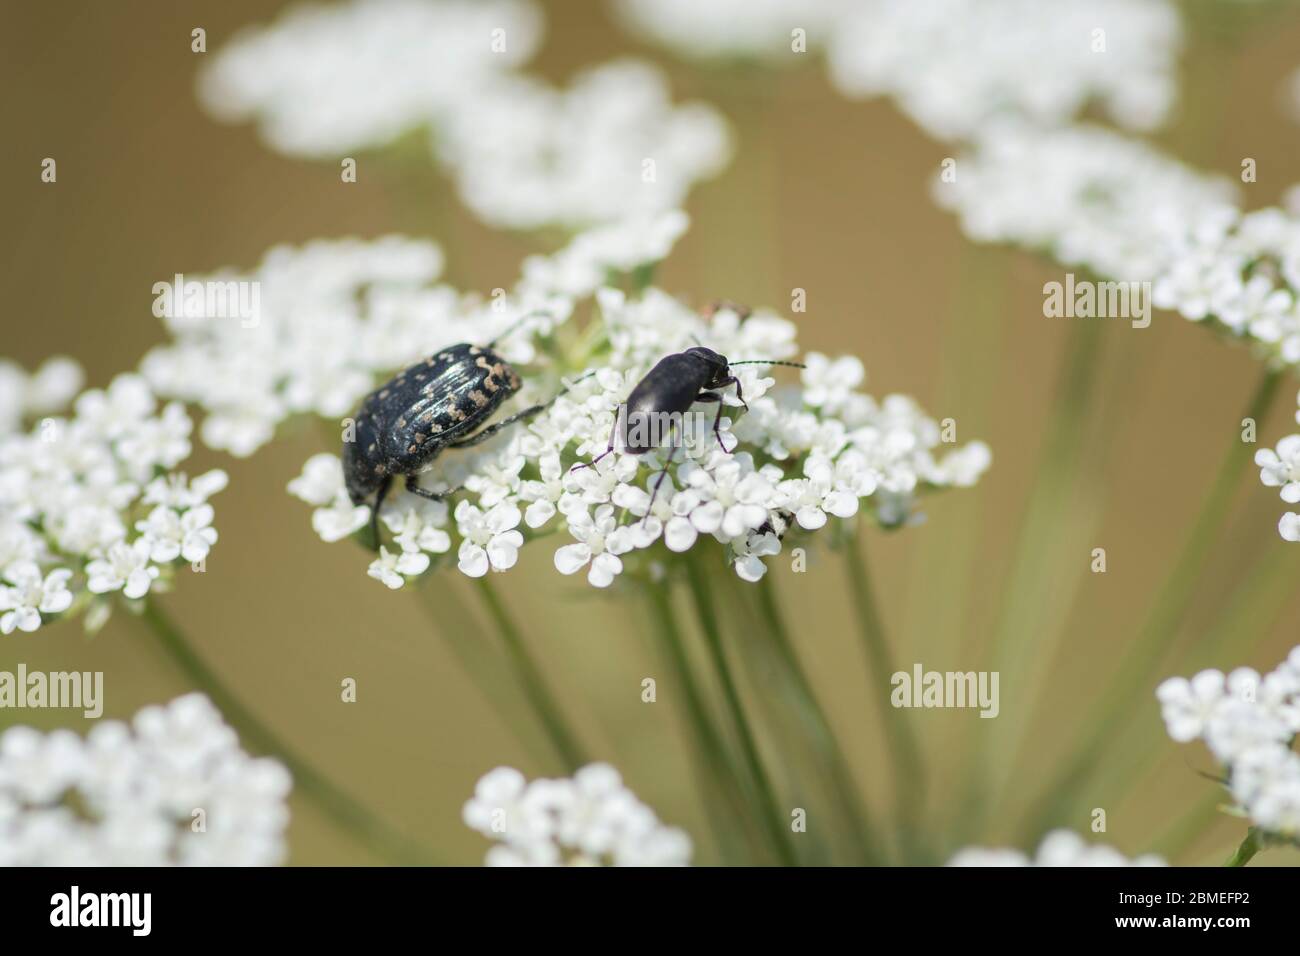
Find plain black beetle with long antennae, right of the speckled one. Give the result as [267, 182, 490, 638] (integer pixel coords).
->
[575, 345, 803, 522]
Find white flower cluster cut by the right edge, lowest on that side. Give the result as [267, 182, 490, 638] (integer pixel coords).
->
[1156, 648, 1300, 840]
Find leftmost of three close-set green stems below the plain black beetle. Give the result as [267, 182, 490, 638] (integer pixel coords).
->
[644, 581, 753, 864]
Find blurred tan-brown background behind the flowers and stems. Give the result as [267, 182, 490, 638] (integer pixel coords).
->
[0, 0, 1300, 864]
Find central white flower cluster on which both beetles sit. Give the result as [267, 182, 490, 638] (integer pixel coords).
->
[274, 213, 989, 588]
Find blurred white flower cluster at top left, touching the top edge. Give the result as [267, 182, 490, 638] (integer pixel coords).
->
[199, 0, 542, 160]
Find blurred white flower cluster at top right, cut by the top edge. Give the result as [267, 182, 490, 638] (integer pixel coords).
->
[828, 0, 1180, 139]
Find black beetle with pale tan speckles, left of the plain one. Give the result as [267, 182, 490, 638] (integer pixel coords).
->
[343, 316, 546, 548]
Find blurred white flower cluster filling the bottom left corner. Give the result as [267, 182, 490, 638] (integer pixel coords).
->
[0, 693, 290, 866]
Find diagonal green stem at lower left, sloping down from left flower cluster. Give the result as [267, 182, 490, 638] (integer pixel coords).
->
[139, 601, 436, 865]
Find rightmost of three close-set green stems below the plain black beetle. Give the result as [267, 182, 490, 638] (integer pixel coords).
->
[753, 575, 883, 865]
